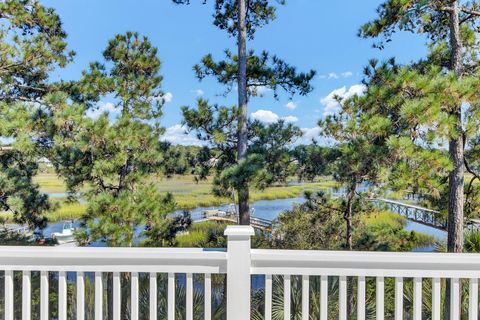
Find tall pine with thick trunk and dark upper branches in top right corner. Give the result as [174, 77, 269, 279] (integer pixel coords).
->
[360, 0, 480, 252]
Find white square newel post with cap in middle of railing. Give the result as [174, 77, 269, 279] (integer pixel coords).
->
[225, 226, 254, 320]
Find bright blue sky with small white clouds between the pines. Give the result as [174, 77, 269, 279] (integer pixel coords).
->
[42, 0, 426, 144]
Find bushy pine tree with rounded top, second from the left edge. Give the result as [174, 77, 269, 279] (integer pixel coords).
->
[54, 32, 174, 246]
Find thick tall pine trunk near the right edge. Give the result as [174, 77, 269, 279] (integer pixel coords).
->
[444, 0, 465, 319]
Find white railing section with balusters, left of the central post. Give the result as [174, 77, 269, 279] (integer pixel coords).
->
[0, 247, 227, 320]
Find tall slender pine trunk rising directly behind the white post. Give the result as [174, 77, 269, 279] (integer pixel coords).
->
[237, 0, 250, 225]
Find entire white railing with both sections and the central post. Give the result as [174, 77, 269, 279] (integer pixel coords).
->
[0, 226, 480, 320]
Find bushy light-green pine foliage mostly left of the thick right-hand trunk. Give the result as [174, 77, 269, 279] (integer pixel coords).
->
[334, 53, 480, 315]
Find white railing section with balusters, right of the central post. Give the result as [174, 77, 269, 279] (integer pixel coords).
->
[251, 250, 480, 320]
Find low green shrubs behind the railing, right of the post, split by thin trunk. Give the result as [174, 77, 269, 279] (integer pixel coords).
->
[267, 193, 433, 251]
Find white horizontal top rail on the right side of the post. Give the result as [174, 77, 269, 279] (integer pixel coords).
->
[251, 249, 480, 278]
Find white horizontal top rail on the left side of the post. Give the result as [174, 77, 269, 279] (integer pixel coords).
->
[0, 247, 227, 273]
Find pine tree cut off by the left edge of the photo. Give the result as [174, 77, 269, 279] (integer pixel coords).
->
[0, 0, 74, 228]
